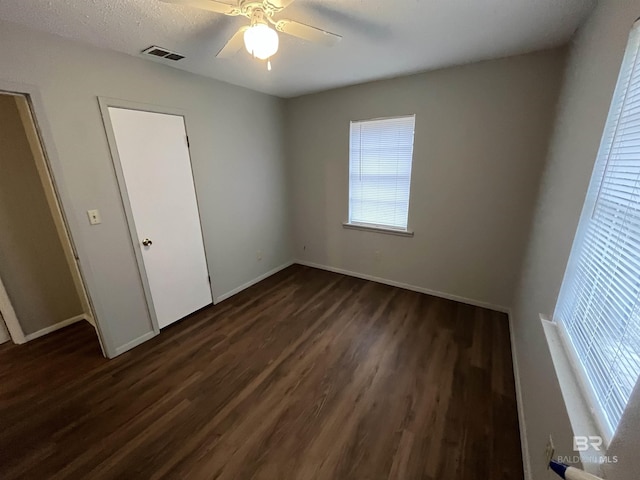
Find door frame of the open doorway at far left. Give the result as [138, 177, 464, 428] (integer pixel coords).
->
[0, 79, 110, 356]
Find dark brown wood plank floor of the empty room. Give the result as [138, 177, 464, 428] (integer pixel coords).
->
[0, 265, 523, 480]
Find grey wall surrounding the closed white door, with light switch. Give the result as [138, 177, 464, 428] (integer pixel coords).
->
[0, 22, 292, 356]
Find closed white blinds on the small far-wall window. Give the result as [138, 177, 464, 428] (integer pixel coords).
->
[349, 115, 415, 230]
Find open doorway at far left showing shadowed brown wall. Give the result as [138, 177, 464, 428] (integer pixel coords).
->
[0, 91, 99, 352]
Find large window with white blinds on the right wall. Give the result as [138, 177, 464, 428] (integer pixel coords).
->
[554, 26, 640, 437]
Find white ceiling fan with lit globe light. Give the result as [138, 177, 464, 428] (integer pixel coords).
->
[161, 0, 342, 70]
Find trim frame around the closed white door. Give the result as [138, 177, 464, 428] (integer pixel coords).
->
[98, 96, 214, 334]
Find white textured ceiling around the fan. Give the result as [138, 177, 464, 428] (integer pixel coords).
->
[0, 0, 595, 97]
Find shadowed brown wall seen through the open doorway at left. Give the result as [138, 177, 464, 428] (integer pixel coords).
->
[0, 95, 82, 335]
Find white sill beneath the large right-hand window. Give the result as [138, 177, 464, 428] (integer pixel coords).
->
[540, 315, 611, 475]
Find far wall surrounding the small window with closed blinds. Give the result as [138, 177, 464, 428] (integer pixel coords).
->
[286, 49, 565, 307]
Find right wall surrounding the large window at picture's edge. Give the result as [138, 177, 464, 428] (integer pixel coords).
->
[512, 0, 640, 480]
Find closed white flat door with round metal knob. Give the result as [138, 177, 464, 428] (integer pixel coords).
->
[109, 107, 212, 328]
